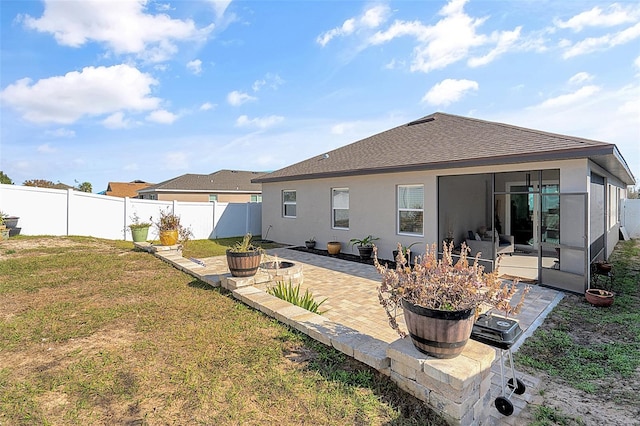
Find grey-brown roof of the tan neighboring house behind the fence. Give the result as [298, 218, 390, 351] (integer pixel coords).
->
[138, 170, 264, 194]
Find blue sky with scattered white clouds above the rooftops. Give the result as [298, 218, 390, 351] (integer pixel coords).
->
[0, 0, 640, 192]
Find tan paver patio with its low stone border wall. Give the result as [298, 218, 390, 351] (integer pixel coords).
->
[141, 246, 563, 425]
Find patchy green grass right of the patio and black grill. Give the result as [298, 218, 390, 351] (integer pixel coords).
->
[516, 241, 640, 402]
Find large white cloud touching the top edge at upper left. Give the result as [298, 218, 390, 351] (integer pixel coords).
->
[22, 0, 213, 62]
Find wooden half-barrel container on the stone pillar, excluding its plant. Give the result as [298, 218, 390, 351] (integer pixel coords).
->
[402, 299, 475, 358]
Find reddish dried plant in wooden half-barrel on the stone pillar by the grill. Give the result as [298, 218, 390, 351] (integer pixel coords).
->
[374, 243, 529, 358]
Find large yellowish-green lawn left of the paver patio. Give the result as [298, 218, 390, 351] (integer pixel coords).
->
[0, 237, 442, 425]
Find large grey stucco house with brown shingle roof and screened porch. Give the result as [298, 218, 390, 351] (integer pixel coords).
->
[254, 113, 635, 293]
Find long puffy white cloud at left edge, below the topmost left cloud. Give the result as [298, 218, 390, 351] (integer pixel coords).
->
[0, 64, 160, 124]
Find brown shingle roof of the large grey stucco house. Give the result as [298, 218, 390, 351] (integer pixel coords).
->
[254, 112, 635, 185]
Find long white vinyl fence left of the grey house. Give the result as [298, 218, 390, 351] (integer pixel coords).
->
[0, 184, 262, 240]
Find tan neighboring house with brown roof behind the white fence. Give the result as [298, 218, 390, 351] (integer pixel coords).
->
[138, 170, 264, 203]
